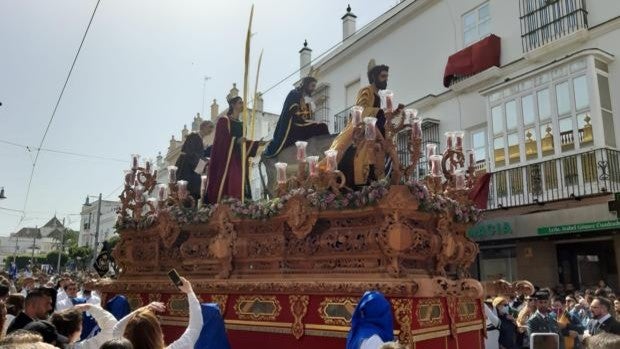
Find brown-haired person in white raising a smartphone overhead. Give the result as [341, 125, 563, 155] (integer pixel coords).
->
[114, 271, 203, 349]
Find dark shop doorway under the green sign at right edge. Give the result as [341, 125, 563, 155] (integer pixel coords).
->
[557, 239, 618, 288]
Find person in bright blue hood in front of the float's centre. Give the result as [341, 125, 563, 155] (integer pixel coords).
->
[346, 291, 394, 349]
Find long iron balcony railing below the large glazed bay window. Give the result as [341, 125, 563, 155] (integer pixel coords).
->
[488, 148, 620, 210]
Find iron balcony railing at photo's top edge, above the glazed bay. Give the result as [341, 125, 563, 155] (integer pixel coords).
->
[519, 0, 588, 52]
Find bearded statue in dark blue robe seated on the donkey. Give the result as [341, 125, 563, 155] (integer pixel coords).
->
[263, 77, 329, 158]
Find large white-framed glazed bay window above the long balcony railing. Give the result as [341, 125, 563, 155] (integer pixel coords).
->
[489, 58, 594, 168]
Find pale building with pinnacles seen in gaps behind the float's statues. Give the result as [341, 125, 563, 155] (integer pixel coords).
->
[155, 84, 280, 199]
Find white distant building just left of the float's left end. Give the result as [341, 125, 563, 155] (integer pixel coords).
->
[78, 199, 121, 249]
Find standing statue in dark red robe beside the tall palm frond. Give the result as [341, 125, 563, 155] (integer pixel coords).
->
[207, 97, 259, 204]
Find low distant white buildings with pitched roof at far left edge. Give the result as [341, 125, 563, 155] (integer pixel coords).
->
[0, 216, 65, 265]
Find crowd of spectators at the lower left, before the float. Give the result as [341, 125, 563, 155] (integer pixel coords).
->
[0, 274, 220, 349]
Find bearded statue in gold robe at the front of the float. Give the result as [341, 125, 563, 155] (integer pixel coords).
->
[330, 60, 403, 188]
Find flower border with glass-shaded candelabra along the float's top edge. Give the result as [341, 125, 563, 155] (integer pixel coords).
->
[117, 91, 482, 230]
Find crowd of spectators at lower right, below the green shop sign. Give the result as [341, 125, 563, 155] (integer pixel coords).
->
[484, 280, 620, 349]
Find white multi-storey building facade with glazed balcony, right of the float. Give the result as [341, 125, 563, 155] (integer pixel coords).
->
[300, 0, 620, 286]
